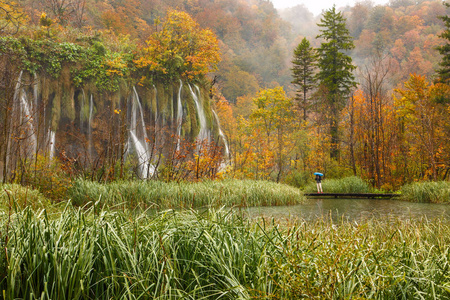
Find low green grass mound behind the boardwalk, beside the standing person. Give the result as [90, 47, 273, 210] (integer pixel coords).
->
[305, 176, 371, 194]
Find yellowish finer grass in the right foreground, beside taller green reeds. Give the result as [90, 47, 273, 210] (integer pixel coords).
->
[277, 216, 450, 299]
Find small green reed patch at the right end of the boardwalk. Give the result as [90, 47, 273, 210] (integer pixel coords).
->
[401, 181, 450, 203]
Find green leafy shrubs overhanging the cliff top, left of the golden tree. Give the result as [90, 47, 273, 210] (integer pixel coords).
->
[0, 37, 133, 91]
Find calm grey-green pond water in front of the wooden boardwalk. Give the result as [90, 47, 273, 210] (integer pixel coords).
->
[242, 198, 450, 221]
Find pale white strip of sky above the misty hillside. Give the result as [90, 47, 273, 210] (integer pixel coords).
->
[271, 0, 389, 16]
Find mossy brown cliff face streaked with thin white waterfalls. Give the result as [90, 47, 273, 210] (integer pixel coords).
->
[0, 69, 228, 178]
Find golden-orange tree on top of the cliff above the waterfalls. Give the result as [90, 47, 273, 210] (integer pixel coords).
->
[135, 10, 220, 80]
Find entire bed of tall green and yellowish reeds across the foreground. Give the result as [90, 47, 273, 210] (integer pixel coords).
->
[0, 206, 450, 299]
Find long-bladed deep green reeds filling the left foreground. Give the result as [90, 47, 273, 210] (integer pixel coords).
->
[0, 208, 277, 299]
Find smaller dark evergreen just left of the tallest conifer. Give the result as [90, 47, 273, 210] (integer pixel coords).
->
[291, 38, 316, 121]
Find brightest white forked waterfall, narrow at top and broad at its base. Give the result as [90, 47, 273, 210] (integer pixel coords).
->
[130, 87, 155, 178]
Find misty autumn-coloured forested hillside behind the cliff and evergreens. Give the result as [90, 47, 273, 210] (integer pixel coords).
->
[12, 0, 446, 98]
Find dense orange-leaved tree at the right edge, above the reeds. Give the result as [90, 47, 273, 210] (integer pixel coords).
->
[395, 74, 450, 180]
